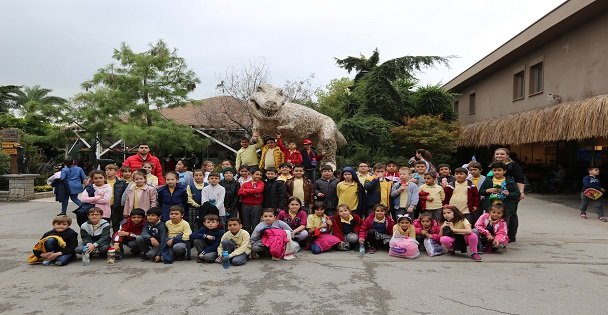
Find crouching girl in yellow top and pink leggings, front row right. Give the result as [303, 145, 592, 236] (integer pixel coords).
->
[439, 206, 481, 261]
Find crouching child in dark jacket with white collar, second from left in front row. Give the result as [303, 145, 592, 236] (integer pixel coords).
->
[76, 207, 110, 256]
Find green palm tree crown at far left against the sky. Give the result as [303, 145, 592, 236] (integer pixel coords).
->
[11, 85, 67, 121]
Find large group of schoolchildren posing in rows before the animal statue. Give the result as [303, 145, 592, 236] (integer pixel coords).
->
[30, 152, 519, 265]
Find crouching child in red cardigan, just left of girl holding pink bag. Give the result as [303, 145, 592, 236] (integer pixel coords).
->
[359, 204, 395, 254]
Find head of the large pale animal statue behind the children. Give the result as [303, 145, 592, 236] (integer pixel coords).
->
[248, 84, 287, 119]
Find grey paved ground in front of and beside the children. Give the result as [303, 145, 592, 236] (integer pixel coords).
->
[0, 197, 608, 314]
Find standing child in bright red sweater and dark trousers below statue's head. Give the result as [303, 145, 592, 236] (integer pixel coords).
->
[239, 170, 264, 231]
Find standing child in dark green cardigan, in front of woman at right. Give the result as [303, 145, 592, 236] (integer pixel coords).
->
[479, 162, 520, 243]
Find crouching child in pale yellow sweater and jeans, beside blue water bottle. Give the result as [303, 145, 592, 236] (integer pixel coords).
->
[215, 217, 251, 266]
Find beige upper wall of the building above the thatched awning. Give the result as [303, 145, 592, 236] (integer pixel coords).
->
[454, 13, 608, 124]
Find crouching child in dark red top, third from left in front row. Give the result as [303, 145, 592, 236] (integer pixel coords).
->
[108, 208, 146, 264]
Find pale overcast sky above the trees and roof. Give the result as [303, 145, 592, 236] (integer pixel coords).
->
[0, 0, 564, 98]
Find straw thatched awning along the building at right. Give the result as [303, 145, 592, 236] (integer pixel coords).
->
[458, 94, 608, 147]
